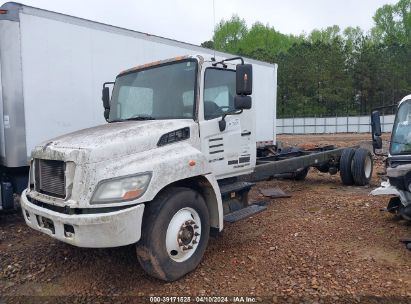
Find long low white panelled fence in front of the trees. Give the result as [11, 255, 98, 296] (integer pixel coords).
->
[276, 115, 394, 134]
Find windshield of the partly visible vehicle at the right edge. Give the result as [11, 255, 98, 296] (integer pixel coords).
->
[390, 99, 411, 155]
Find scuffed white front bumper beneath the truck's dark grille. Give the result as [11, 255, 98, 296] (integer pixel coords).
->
[20, 191, 144, 248]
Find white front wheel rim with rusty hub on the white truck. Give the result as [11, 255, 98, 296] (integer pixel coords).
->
[166, 207, 201, 262]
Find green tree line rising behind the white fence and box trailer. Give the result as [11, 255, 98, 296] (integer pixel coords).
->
[202, 0, 411, 117]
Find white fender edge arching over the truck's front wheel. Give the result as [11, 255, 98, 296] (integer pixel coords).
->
[157, 176, 220, 228]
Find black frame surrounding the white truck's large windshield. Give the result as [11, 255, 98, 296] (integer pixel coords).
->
[107, 57, 200, 123]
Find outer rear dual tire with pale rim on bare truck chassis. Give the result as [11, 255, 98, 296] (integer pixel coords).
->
[352, 148, 373, 186]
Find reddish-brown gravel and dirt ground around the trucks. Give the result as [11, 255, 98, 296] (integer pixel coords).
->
[0, 134, 411, 303]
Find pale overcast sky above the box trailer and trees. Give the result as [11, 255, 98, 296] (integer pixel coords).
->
[10, 0, 397, 45]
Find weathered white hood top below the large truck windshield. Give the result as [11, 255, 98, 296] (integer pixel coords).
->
[32, 119, 195, 163]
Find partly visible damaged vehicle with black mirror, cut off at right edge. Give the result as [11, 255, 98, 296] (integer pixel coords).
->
[371, 95, 411, 220]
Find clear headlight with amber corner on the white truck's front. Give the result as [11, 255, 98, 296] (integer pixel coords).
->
[91, 173, 151, 204]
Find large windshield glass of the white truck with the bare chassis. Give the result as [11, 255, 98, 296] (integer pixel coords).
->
[109, 60, 197, 122]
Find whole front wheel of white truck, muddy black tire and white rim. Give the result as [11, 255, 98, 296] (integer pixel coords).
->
[137, 187, 210, 281]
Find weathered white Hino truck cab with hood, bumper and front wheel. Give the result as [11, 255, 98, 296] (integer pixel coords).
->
[21, 56, 258, 281]
